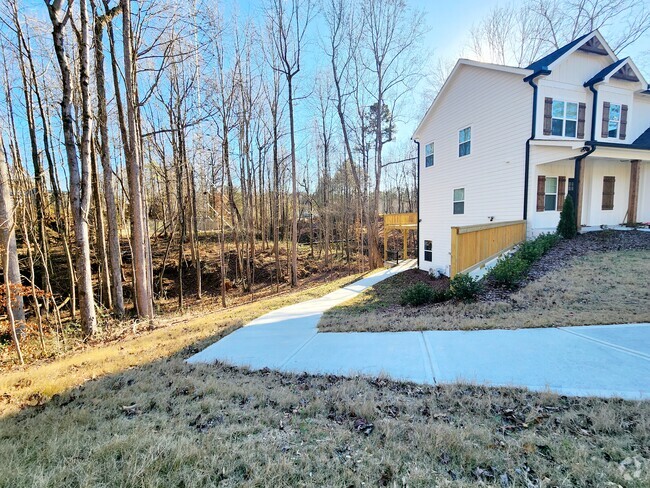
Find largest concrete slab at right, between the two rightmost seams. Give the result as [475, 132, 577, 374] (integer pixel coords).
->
[423, 329, 650, 399]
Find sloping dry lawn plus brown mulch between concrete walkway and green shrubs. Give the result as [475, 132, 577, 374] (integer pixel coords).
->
[319, 231, 650, 332]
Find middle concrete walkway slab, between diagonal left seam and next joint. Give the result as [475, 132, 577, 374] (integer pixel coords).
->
[282, 332, 434, 384]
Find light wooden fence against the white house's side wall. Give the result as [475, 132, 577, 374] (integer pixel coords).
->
[451, 220, 526, 277]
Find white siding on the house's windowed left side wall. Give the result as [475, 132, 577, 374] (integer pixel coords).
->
[415, 65, 532, 273]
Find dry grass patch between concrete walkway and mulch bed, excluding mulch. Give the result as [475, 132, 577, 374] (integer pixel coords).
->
[319, 251, 650, 332]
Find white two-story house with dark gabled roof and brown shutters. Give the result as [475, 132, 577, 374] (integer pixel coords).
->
[413, 31, 650, 274]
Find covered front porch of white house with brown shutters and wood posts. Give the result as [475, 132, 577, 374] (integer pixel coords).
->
[529, 154, 650, 235]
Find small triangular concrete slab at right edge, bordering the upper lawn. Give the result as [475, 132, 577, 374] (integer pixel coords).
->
[560, 324, 650, 359]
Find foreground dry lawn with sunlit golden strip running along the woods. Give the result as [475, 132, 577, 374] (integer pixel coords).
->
[0, 268, 650, 488]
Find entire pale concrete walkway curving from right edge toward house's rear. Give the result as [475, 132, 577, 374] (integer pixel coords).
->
[188, 260, 650, 399]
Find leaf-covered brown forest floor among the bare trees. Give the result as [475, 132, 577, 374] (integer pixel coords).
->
[0, 227, 367, 371]
